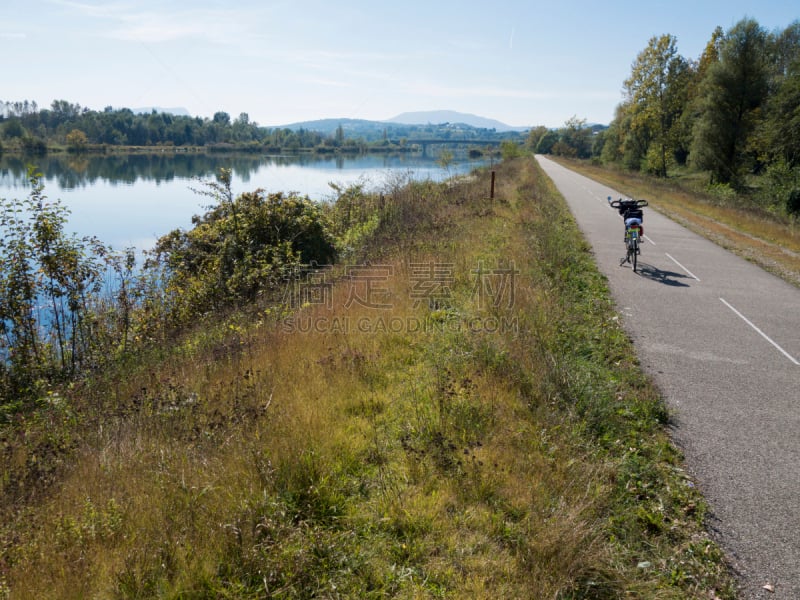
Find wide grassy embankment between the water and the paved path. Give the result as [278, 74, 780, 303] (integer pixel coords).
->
[0, 159, 733, 599]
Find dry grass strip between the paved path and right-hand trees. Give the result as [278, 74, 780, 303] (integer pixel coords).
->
[558, 159, 800, 286]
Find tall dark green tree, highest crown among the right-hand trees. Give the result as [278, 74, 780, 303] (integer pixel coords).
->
[691, 19, 770, 187]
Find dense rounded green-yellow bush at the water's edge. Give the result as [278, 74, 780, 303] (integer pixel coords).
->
[149, 170, 336, 318]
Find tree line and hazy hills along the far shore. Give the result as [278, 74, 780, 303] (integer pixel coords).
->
[0, 100, 524, 154]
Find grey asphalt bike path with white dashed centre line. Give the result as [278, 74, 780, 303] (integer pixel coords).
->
[537, 156, 800, 600]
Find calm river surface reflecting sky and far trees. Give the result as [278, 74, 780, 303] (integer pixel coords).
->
[0, 153, 488, 250]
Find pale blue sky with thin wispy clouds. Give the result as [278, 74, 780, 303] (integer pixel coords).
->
[0, 0, 800, 127]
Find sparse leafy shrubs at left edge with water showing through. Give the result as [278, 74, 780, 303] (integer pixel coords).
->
[0, 168, 124, 404]
